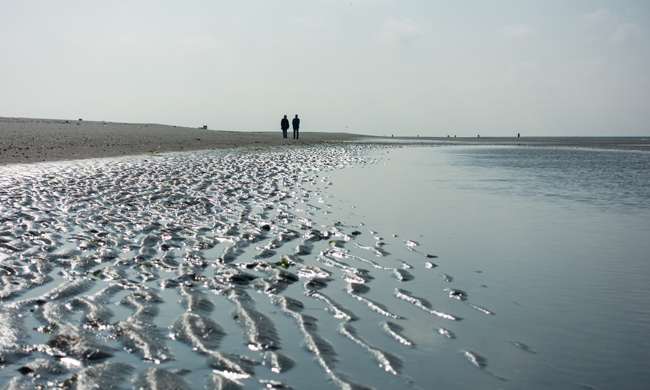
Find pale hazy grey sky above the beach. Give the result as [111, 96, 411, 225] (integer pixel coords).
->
[0, 0, 650, 137]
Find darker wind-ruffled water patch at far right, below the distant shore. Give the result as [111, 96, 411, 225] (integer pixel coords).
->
[452, 148, 650, 209]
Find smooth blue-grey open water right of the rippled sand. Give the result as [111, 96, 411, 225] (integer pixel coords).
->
[331, 146, 650, 388]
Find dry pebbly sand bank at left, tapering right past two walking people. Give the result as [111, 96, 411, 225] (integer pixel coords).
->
[0, 118, 369, 165]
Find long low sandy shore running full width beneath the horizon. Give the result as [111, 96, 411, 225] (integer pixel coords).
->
[0, 117, 650, 165]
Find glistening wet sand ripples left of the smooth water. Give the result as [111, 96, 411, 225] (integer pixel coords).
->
[0, 145, 501, 389]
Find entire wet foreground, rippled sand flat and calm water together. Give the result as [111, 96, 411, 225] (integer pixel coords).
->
[0, 145, 650, 389]
